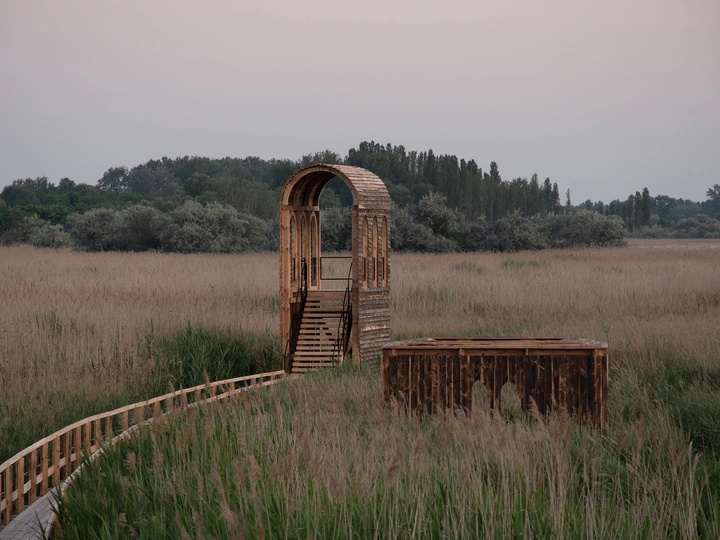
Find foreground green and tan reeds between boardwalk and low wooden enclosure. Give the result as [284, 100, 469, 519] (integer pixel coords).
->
[54, 367, 720, 539]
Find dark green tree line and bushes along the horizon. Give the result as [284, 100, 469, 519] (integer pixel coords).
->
[0, 142, 720, 252]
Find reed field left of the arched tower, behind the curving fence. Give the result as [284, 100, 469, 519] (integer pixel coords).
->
[0, 247, 280, 462]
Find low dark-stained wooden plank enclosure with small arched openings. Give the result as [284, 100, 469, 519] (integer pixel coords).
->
[382, 338, 608, 431]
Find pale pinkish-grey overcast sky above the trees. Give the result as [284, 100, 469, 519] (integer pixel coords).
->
[0, 0, 720, 203]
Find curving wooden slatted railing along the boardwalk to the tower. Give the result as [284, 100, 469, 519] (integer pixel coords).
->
[0, 371, 285, 529]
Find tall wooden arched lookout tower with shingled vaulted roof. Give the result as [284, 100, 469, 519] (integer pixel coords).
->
[280, 164, 390, 373]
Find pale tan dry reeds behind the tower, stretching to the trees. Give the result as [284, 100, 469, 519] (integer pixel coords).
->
[0, 241, 720, 457]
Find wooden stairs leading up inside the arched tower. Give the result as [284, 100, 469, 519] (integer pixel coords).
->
[290, 291, 351, 373]
